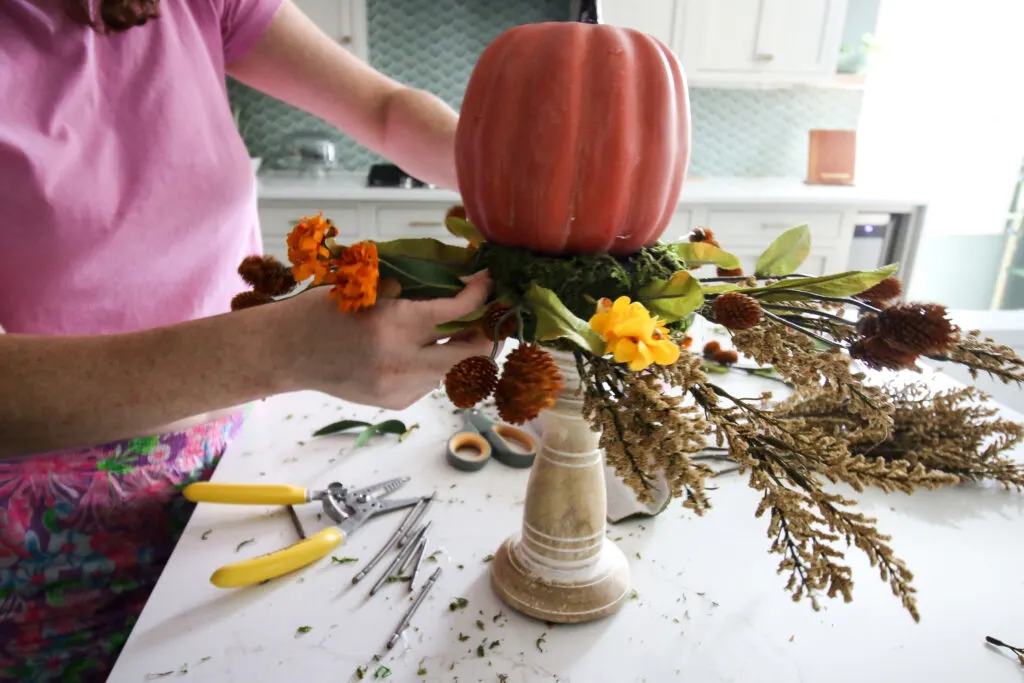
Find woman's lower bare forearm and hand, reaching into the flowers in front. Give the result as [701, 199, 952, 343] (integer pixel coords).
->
[0, 278, 490, 459]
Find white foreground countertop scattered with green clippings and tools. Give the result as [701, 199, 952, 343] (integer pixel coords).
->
[109, 366, 1024, 683]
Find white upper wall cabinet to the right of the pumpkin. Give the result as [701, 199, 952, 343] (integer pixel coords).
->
[573, 0, 848, 87]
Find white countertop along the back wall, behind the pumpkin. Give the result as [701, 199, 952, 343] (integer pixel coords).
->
[257, 171, 927, 211]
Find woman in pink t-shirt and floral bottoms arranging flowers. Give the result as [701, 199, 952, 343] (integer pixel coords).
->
[0, 0, 489, 681]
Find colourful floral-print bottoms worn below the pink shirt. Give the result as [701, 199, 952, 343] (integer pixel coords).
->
[0, 411, 245, 683]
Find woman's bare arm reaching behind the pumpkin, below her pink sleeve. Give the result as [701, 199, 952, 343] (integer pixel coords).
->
[227, 0, 459, 190]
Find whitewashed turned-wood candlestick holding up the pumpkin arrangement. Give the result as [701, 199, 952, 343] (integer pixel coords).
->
[490, 352, 630, 624]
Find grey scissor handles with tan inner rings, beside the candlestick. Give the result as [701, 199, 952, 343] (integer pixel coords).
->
[444, 408, 537, 472]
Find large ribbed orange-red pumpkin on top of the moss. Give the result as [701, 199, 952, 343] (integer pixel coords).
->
[456, 14, 690, 255]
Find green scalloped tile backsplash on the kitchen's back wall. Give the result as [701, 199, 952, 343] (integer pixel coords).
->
[228, 0, 861, 177]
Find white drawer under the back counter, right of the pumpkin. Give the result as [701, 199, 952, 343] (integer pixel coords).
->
[707, 210, 844, 251]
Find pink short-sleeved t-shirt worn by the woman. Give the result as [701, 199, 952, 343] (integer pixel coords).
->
[0, 0, 282, 334]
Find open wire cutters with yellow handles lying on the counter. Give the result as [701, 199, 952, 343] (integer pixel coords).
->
[182, 477, 423, 588]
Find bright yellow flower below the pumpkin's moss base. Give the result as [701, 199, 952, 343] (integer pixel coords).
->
[590, 296, 680, 372]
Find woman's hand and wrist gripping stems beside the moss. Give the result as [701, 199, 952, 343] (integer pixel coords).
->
[272, 272, 493, 410]
